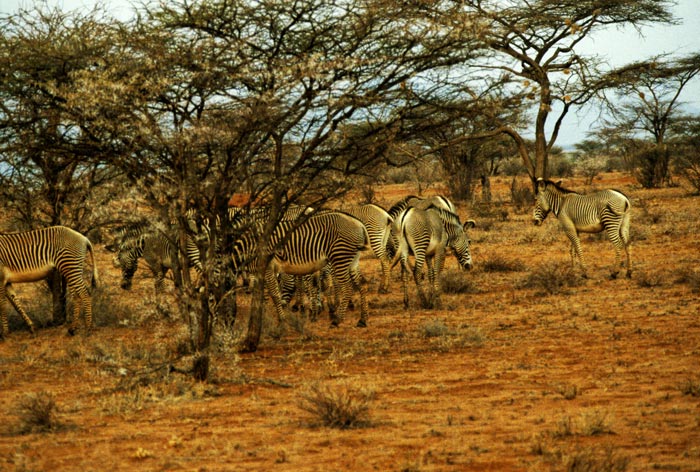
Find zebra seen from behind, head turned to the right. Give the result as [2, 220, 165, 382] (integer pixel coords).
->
[392, 206, 476, 309]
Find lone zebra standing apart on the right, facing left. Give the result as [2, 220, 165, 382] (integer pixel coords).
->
[533, 178, 632, 279]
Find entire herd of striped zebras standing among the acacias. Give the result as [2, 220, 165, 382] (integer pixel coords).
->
[0, 179, 632, 340]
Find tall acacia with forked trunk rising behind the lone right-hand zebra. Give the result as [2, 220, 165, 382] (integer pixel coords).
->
[424, 0, 672, 181]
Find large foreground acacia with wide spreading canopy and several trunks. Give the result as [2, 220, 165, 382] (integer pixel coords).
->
[61, 0, 482, 364]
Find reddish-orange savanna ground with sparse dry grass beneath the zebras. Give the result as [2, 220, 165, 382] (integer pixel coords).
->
[0, 174, 700, 471]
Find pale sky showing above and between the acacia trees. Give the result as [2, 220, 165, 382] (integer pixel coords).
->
[0, 0, 700, 147]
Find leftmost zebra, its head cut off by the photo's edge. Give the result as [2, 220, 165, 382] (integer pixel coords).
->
[0, 226, 97, 339]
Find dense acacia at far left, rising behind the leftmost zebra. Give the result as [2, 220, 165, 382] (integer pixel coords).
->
[0, 7, 124, 322]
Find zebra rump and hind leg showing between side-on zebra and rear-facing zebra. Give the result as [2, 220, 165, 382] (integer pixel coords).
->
[344, 203, 394, 293]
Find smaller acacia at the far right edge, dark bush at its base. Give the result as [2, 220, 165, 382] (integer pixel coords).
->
[605, 53, 700, 188]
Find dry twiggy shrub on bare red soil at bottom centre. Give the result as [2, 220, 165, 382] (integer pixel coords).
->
[299, 384, 375, 429]
